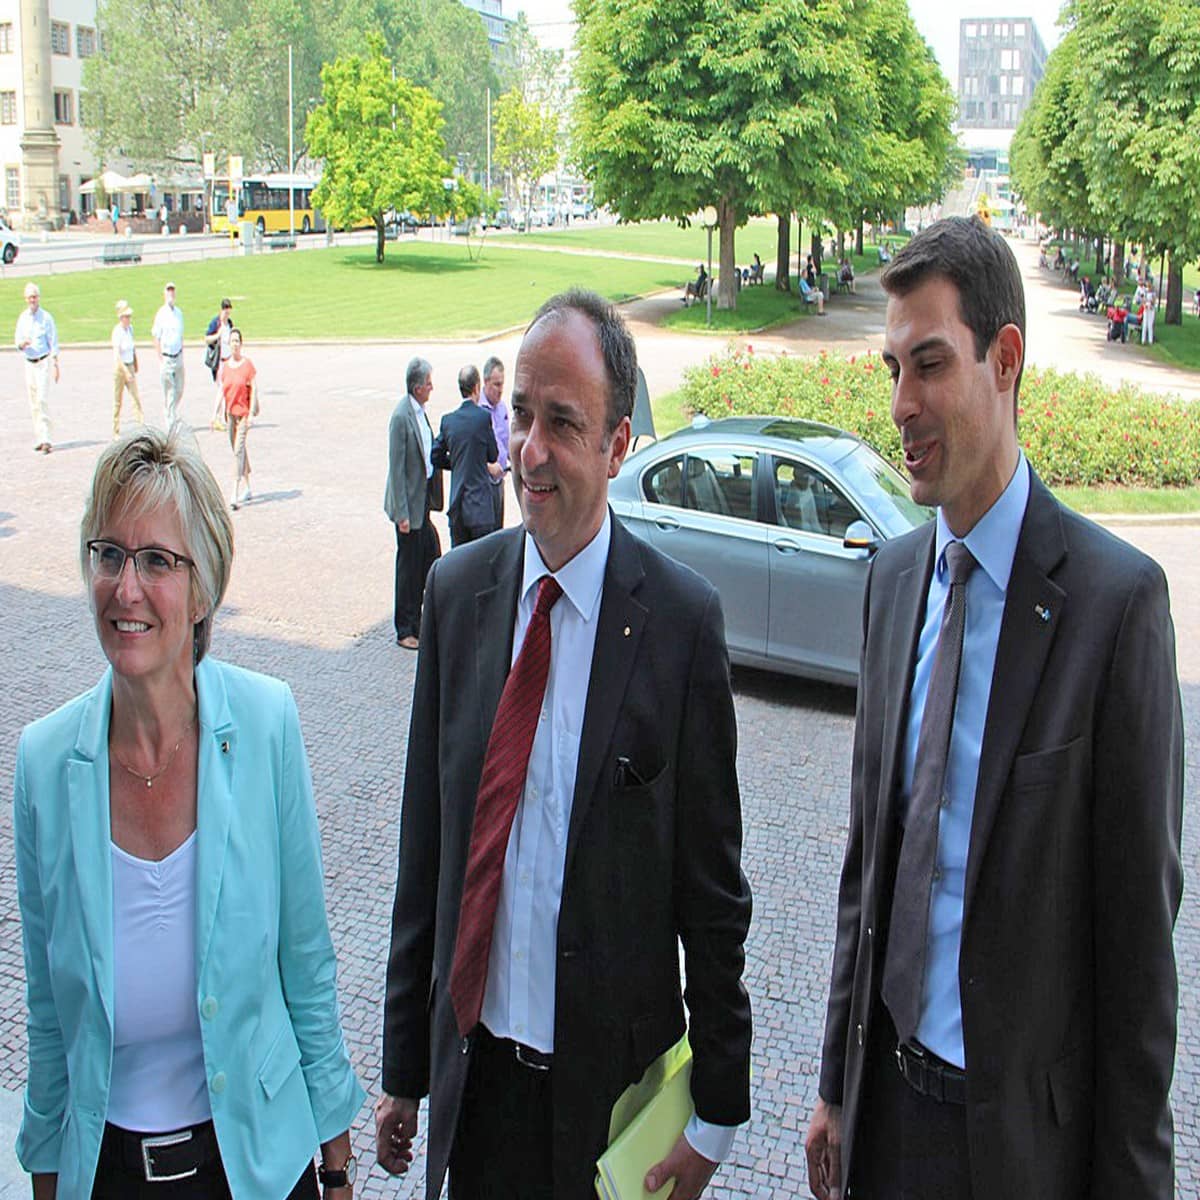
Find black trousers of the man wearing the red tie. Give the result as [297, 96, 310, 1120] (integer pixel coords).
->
[450, 1026, 556, 1200]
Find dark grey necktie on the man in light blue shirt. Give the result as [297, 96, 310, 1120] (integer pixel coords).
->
[883, 541, 976, 1042]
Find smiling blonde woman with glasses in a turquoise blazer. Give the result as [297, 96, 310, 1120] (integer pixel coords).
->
[13, 422, 364, 1200]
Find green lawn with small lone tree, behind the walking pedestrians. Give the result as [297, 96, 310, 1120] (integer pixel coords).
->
[0, 241, 696, 346]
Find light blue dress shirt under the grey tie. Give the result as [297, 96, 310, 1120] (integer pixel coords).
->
[900, 455, 1030, 1067]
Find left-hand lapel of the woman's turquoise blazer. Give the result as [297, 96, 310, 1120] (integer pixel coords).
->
[67, 668, 113, 1027]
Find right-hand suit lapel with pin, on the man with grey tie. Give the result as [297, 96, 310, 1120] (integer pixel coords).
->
[964, 470, 1067, 924]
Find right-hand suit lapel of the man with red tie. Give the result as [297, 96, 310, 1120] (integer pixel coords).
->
[563, 517, 649, 878]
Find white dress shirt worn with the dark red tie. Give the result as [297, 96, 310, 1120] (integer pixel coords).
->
[481, 512, 737, 1162]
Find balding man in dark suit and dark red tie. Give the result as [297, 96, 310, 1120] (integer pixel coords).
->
[376, 293, 750, 1200]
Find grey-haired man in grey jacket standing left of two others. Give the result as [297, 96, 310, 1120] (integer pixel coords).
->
[383, 359, 442, 650]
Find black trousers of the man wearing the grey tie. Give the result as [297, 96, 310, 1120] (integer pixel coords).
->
[850, 1004, 971, 1200]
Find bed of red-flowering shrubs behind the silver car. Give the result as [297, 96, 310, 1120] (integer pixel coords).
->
[683, 347, 1200, 487]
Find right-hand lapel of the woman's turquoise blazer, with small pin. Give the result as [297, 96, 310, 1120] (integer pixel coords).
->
[196, 659, 238, 970]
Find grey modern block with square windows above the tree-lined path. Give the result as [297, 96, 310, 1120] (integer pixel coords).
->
[958, 17, 1046, 131]
